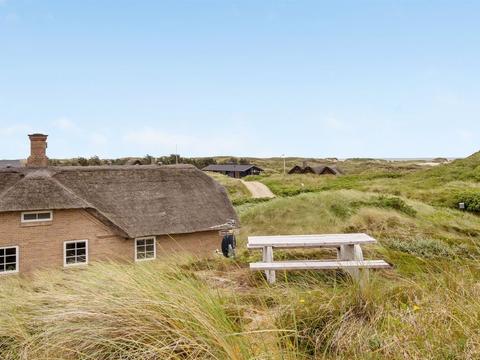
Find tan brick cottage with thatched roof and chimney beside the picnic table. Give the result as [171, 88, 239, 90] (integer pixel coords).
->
[0, 134, 237, 274]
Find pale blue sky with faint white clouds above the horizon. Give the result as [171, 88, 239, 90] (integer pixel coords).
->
[0, 0, 480, 158]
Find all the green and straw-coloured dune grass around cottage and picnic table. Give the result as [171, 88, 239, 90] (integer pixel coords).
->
[0, 154, 480, 360]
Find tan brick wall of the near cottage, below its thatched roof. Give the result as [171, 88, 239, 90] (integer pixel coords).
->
[0, 210, 220, 273]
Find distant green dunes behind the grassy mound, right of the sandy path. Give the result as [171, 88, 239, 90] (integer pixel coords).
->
[257, 152, 480, 207]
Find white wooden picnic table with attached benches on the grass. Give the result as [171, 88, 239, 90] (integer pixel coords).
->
[247, 234, 390, 283]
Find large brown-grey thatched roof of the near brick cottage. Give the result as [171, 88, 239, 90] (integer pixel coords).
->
[0, 165, 237, 238]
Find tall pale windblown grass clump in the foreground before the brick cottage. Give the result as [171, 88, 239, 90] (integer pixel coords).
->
[0, 263, 258, 359]
